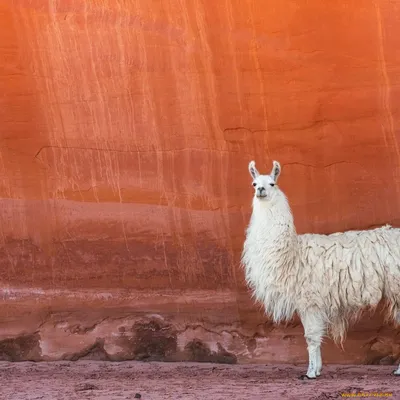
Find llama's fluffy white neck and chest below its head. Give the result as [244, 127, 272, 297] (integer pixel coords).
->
[242, 191, 298, 321]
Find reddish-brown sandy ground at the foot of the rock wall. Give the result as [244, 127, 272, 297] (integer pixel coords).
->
[0, 361, 400, 400]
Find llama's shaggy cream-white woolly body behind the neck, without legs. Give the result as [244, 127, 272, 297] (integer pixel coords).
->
[298, 226, 400, 330]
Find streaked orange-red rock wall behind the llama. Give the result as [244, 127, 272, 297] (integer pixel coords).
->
[0, 0, 400, 363]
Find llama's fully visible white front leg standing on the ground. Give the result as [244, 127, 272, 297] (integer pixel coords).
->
[300, 312, 325, 379]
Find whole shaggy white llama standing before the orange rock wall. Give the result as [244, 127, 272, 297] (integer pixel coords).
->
[242, 161, 400, 379]
